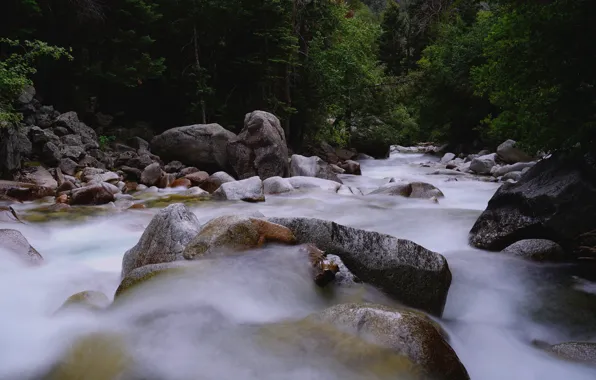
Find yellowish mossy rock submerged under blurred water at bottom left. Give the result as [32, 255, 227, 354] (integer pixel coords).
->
[43, 333, 132, 380]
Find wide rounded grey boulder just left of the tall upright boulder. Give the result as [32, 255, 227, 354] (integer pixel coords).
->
[151, 124, 236, 173]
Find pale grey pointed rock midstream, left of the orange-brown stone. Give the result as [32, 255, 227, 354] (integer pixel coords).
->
[122, 203, 201, 278]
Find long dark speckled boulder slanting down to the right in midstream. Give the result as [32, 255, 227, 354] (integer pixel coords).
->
[268, 218, 451, 316]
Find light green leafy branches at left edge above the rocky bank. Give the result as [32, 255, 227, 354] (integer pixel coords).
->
[0, 38, 72, 123]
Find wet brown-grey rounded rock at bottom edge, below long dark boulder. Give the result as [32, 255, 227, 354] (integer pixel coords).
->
[308, 304, 470, 380]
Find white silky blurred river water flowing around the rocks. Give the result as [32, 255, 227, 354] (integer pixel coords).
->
[0, 154, 596, 380]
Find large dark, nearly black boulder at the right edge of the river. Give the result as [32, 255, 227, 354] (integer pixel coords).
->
[470, 153, 596, 257]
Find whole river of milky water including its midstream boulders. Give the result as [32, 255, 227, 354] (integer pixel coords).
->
[0, 152, 596, 380]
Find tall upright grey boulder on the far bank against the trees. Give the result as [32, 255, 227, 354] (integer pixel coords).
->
[228, 111, 289, 180]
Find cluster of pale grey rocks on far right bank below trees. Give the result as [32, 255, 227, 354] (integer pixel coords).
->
[436, 140, 536, 183]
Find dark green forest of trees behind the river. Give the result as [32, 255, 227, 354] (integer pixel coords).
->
[0, 0, 596, 156]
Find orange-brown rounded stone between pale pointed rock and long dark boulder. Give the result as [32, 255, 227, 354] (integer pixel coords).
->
[184, 215, 296, 260]
